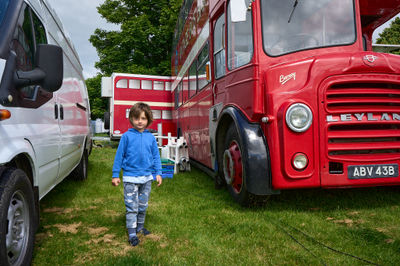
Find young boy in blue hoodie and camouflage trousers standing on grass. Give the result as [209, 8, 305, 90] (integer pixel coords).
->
[112, 103, 162, 246]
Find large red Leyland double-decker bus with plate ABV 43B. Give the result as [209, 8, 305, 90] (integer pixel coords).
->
[172, 0, 400, 204]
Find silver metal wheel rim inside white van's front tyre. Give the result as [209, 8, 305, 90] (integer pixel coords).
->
[6, 191, 29, 265]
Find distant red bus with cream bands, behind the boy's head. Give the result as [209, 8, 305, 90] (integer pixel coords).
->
[102, 73, 176, 139]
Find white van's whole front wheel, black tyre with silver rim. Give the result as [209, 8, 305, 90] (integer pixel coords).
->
[0, 168, 36, 265]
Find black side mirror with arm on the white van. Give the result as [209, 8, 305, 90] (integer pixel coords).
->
[14, 44, 64, 92]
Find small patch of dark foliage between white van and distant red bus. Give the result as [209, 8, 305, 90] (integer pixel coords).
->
[86, 74, 108, 119]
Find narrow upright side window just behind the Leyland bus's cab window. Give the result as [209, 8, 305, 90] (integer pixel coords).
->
[214, 14, 225, 79]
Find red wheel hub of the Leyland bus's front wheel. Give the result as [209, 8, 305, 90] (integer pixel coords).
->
[223, 141, 243, 193]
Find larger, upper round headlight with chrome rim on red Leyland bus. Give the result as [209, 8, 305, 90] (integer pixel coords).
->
[286, 103, 312, 132]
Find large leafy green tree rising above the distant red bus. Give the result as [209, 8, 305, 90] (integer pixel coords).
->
[90, 0, 182, 76]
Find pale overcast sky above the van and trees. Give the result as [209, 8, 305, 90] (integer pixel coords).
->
[47, 0, 398, 78]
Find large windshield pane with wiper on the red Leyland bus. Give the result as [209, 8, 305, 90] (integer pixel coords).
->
[261, 0, 356, 56]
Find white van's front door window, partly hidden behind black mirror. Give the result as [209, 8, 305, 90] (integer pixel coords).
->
[11, 4, 53, 108]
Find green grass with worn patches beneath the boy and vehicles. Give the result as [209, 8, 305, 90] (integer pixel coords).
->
[33, 147, 400, 265]
